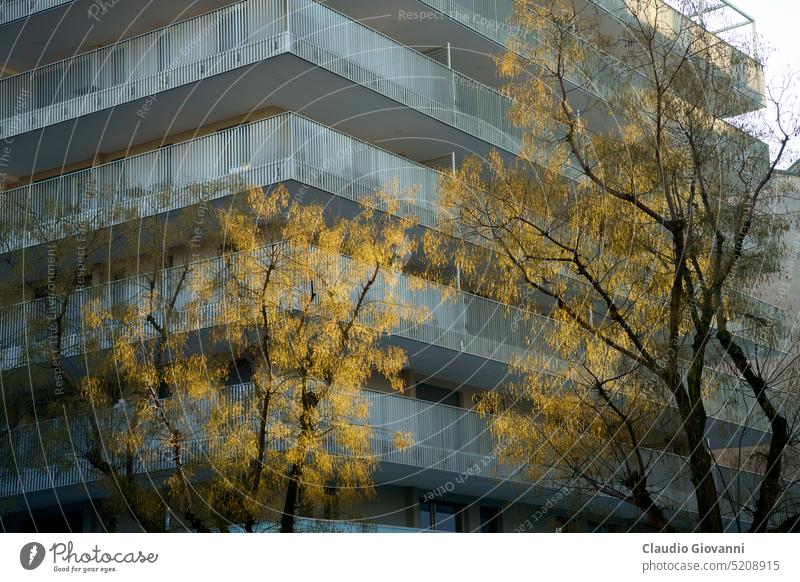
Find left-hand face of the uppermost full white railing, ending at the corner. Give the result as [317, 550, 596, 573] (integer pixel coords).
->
[0, 0, 285, 137]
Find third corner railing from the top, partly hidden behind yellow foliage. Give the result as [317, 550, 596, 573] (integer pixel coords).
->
[0, 237, 780, 434]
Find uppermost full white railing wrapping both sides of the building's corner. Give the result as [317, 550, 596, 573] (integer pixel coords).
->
[0, 0, 519, 152]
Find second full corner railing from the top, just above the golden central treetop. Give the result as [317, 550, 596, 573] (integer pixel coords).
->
[0, 113, 439, 250]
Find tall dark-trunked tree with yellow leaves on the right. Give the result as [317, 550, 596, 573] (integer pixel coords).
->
[426, 0, 798, 531]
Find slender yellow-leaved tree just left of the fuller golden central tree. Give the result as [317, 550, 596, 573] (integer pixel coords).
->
[82, 183, 226, 531]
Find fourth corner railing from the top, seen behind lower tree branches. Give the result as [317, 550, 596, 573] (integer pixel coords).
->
[0, 384, 788, 524]
